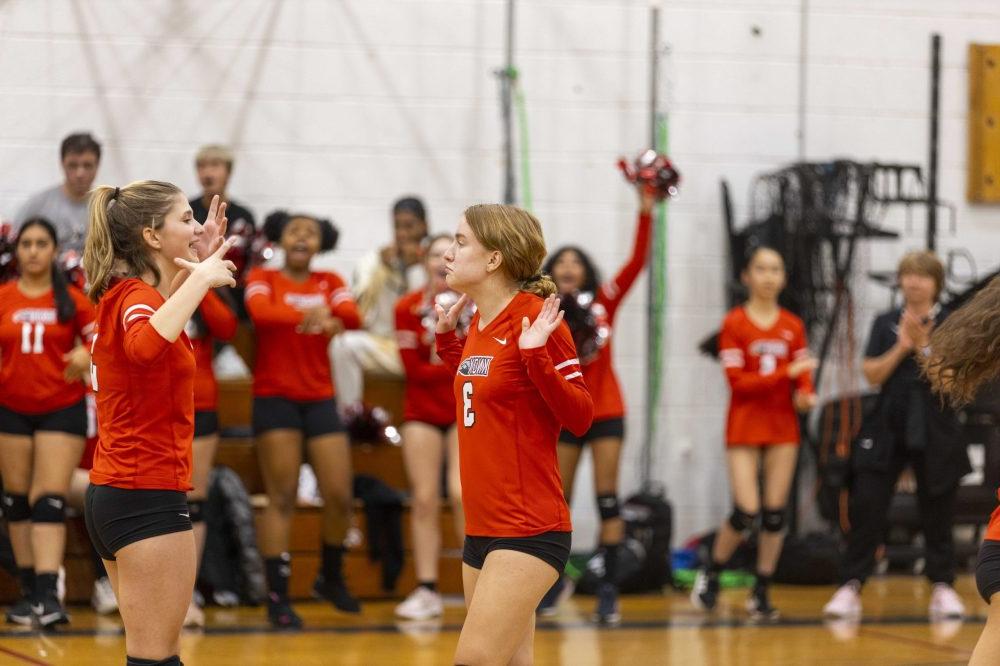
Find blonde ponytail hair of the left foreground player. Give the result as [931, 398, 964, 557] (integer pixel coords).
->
[83, 180, 182, 303]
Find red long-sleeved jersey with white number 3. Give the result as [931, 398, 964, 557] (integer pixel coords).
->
[437, 292, 594, 537]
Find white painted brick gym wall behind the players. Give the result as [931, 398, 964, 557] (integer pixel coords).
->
[0, 0, 1000, 548]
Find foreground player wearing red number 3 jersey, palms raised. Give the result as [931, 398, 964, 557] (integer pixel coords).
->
[436, 204, 594, 665]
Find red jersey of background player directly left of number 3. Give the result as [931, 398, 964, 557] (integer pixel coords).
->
[396, 290, 455, 426]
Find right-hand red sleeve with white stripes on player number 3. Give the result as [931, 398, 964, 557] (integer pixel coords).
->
[521, 323, 594, 436]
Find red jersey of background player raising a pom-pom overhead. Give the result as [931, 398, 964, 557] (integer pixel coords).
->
[583, 214, 653, 421]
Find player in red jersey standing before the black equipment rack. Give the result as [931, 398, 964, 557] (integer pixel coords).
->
[691, 247, 816, 619]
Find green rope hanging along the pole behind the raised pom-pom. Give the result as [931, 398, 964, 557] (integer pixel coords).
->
[646, 114, 670, 442]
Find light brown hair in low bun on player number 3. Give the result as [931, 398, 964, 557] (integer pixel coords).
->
[465, 204, 556, 298]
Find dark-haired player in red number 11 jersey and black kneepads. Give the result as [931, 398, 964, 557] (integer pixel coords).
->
[0, 218, 94, 627]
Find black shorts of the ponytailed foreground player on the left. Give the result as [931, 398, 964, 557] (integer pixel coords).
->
[83, 484, 191, 560]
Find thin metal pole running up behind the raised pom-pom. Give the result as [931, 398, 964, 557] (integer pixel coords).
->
[641, 0, 661, 487]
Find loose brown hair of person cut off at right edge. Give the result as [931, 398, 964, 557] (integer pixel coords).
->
[921, 277, 1000, 407]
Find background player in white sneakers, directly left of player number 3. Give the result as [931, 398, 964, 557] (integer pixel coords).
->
[396, 234, 465, 620]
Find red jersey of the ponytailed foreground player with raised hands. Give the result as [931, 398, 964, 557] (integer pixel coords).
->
[90, 278, 195, 491]
